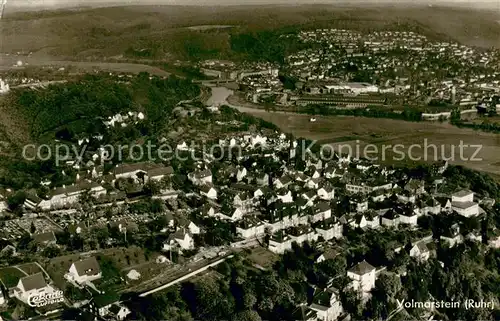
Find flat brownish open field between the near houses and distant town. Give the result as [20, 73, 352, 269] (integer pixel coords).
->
[232, 107, 500, 175]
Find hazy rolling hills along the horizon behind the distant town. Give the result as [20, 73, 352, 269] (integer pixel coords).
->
[0, 5, 500, 60]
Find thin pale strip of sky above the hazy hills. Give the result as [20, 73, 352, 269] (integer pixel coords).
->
[0, 0, 500, 9]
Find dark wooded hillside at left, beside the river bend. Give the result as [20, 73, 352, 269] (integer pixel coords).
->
[14, 73, 199, 140]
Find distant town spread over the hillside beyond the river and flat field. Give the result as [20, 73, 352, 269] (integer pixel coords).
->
[198, 29, 500, 116]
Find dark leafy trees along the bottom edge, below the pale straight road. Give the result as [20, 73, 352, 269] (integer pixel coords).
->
[122, 235, 500, 321]
